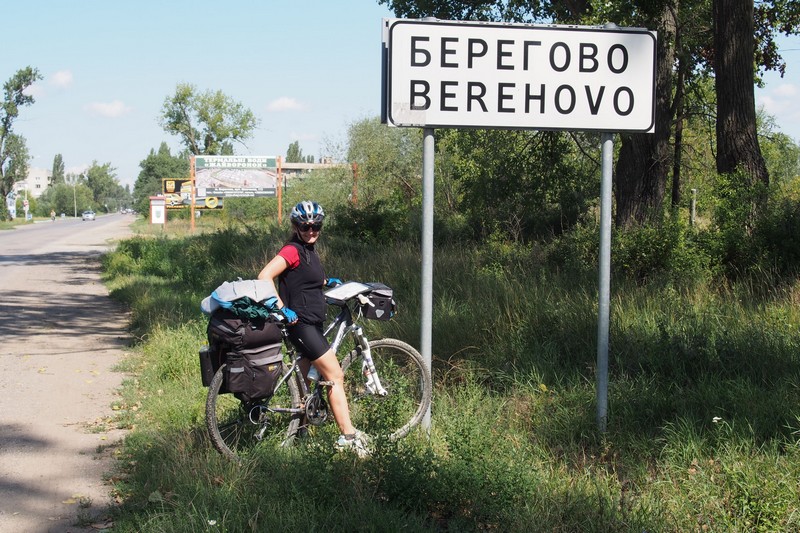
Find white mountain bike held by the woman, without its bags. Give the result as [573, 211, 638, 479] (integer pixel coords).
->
[206, 282, 432, 460]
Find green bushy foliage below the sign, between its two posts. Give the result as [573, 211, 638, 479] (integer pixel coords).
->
[436, 130, 599, 240]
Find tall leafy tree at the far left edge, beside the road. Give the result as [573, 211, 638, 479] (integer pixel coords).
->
[0, 67, 42, 220]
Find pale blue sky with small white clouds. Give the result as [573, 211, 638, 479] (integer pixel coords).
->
[0, 0, 800, 189]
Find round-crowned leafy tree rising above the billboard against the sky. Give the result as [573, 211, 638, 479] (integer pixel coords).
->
[159, 83, 259, 155]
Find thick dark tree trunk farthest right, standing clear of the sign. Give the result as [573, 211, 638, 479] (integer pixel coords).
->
[713, 0, 769, 203]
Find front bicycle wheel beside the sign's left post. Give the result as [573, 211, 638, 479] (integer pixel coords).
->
[342, 339, 432, 441]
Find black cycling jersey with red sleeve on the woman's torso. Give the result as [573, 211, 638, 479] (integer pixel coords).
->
[278, 236, 327, 324]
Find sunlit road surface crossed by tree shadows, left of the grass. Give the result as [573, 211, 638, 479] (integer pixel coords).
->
[0, 214, 134, 533]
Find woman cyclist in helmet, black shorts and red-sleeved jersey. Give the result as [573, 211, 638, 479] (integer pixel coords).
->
[258, 201, 369, 457]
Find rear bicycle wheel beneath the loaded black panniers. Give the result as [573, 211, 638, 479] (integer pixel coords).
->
[206, 363, 302, 461]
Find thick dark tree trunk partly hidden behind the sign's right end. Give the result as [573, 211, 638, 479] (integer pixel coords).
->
[615, 9, 675, 227]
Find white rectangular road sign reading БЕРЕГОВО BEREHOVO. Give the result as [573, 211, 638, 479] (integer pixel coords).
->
[383, 19, 656, 132]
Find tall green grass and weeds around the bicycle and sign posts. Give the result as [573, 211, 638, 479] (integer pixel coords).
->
[100, 228, 800, 532]
